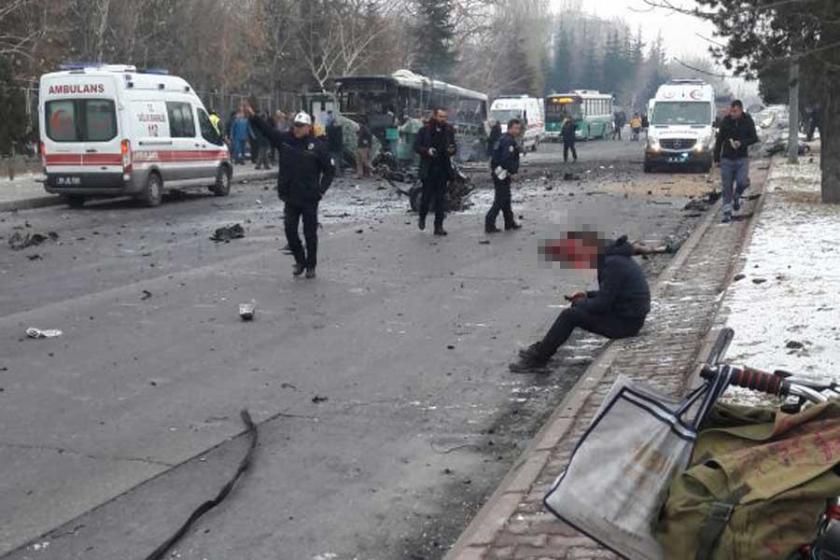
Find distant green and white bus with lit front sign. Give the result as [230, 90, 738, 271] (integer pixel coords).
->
[545, 89, 613, 141]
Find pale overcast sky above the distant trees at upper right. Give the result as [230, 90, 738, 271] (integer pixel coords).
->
[552, 0, 712, 58]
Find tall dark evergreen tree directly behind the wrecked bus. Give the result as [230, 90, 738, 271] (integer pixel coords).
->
[414, 0, 456, 80]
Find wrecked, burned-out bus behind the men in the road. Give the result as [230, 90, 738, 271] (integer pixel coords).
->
[334, 70, 487, 164]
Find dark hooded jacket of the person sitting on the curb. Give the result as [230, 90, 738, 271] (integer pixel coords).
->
[576, 235, 650, 319]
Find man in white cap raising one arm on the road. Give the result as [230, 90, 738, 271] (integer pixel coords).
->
[245, 105, 335, 278]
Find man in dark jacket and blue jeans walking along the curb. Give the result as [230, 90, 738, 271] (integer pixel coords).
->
[713, 99, 758, 224]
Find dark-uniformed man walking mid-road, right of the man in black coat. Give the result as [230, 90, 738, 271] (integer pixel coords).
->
[484, 119, 522, 233]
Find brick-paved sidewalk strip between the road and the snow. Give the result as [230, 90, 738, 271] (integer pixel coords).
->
[447, 161, 768, 560]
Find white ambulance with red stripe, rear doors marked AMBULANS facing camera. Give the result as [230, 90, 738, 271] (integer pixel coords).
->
[38, 65, 233, 206]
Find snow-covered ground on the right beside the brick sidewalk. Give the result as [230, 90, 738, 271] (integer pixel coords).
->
[723, 156, 840, 396]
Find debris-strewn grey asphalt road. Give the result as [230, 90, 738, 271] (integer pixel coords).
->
[0, 138, 705, 560]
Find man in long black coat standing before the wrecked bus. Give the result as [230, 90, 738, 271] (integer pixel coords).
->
[414, 108, 458, 235]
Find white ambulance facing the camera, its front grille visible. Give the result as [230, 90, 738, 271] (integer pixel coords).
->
[644, 79, 715, 173]
